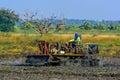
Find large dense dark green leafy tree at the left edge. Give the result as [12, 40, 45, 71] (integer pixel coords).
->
[0, 9, 19, 32]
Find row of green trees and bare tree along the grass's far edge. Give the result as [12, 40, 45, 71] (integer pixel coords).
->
[0, 9, 120, 34]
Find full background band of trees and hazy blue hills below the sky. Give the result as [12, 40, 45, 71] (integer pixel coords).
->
[0, 9, 120, 34]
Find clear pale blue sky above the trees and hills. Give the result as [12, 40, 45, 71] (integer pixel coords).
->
[0, 0, 120, 20]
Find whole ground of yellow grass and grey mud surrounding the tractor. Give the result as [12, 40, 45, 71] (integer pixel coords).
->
[0, 33, 120, 80]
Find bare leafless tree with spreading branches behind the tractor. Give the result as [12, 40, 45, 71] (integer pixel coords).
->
[20, 11, 64, 35]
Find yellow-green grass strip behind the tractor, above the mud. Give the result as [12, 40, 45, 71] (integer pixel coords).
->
[0, 33, 120, 56]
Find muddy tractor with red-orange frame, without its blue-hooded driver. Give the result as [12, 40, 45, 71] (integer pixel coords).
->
[25, 36, 99, 66]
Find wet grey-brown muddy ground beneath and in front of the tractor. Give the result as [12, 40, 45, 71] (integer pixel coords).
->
[0, 57, 120, 80]
